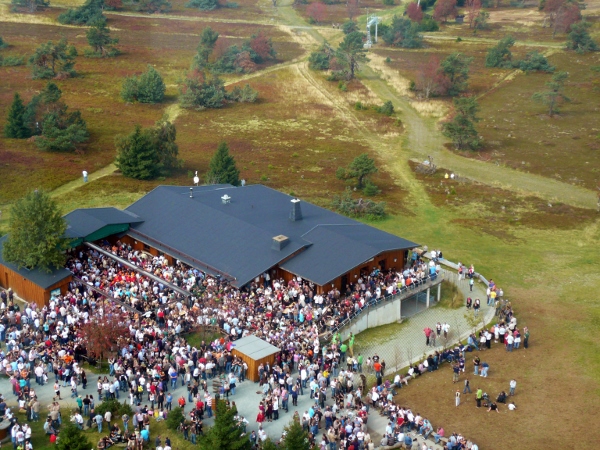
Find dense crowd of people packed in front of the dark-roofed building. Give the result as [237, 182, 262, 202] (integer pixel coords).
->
[0, 241, 528, 448]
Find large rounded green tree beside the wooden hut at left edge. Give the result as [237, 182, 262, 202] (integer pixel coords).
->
[2, 190, 69, 270]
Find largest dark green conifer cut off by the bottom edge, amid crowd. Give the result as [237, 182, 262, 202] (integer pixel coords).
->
[198, 400, 252, 450]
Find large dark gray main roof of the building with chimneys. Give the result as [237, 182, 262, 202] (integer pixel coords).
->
[127, 185, 417, 286]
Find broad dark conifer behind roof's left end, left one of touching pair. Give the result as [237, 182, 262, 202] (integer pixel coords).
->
[116, 125, 161, 180]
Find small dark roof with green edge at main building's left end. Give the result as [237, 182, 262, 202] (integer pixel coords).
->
[64, 208, 142, 238]
